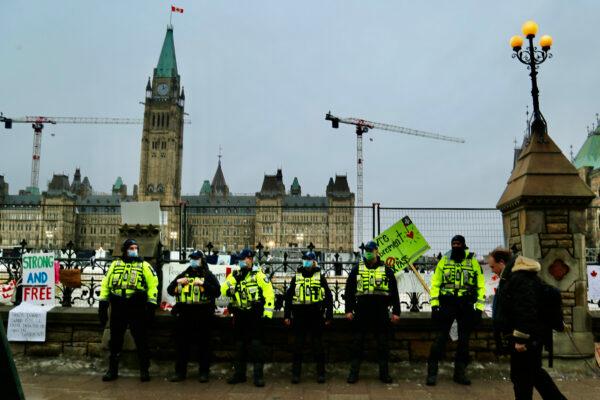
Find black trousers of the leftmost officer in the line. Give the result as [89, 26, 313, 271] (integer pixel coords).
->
[109, 296, 150, 370]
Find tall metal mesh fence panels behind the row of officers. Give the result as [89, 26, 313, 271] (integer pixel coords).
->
[0, 200, 503, 312]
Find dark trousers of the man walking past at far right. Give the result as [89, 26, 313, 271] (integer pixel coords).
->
[510, 342, 566, 400]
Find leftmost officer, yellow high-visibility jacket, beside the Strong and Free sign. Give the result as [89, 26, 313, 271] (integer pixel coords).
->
[98, 239, 158, 382]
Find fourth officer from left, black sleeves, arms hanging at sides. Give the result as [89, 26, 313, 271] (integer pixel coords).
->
[284, 251, 333, 383]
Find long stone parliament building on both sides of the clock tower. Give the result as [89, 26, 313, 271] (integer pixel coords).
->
[0, 163, 354, 252]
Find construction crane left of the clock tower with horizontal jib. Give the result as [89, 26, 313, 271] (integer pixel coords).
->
[0, 113, 191, 190]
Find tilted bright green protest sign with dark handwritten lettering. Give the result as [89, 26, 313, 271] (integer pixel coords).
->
[373, 216, 430, 272]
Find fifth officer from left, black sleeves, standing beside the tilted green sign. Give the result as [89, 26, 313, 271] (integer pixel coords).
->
[345, 241, 400, 383]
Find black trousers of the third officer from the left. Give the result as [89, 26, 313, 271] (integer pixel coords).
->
[233, 308, 264, 375]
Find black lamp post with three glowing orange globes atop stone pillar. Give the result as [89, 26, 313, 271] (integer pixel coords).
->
[510, 21, 552, 143]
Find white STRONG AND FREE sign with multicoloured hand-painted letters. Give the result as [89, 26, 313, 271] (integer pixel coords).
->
[21, 253, 55, 305]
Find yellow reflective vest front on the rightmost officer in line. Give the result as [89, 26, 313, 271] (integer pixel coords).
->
[440, 254, 477, 297]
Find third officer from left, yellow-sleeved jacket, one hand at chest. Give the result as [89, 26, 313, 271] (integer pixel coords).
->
[221, 248, 275, 387]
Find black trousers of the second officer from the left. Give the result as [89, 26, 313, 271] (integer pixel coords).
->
[175, 304, 214, 375]
